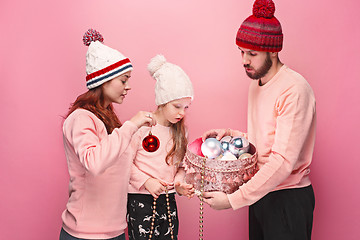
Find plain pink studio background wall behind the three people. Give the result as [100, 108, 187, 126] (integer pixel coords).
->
[0, 0, 360, 240]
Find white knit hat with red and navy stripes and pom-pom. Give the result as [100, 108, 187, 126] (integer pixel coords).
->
[83, 29, 133, 89]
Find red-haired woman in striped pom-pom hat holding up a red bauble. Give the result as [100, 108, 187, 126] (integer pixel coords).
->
[60, 29, 156, 240]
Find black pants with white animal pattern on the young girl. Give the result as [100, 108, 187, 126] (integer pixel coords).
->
[127, 193, 179, 240]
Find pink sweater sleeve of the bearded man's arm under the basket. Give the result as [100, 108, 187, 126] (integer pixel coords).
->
[228, 86, 315, 209]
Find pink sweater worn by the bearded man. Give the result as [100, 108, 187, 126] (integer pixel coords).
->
[228, 65, 316, 209]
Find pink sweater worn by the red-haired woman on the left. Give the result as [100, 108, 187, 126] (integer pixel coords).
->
[62, 109, 137, 239]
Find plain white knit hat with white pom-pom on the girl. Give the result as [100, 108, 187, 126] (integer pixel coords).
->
[148, 55, 194, 106]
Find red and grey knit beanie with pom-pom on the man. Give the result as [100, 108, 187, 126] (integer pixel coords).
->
[236, 0, 283, 52]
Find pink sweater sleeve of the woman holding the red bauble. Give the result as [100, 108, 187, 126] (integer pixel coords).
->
[63, 112, 137, 175]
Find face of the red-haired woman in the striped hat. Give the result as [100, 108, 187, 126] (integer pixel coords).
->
[102, 71, 131, 107]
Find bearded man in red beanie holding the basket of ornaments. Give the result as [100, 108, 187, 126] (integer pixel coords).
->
[203, 0, 316, 240]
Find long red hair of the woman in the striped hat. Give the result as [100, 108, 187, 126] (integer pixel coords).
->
[66, 86, 121, 134]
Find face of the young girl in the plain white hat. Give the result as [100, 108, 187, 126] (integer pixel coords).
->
[160, 97, 191, 126]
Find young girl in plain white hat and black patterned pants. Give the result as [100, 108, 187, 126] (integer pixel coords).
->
[127, 55, 194, 240]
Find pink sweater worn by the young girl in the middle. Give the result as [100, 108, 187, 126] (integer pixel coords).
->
[126, 124, 185, 194]
